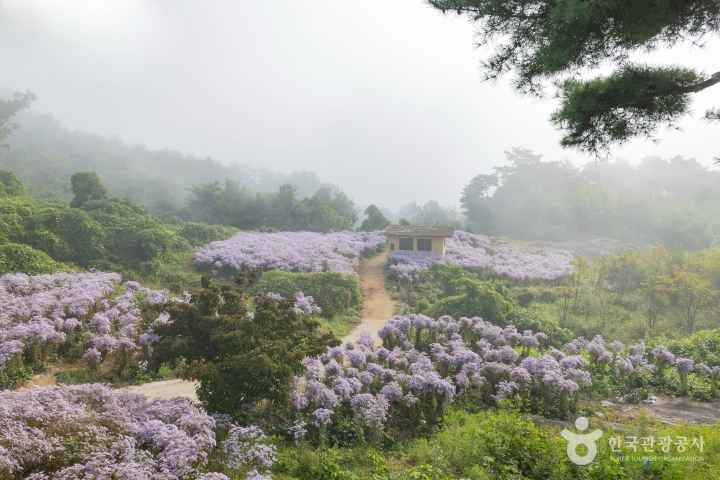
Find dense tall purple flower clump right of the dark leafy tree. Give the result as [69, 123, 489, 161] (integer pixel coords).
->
[293, 315, 590, 433]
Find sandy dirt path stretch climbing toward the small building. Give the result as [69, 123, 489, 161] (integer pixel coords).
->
[343, 252, 395, 342]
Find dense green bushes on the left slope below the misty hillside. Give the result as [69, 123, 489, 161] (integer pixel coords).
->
[0, 172, 234, 280]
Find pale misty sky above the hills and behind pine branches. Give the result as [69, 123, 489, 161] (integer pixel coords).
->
[0, 0, 720, 207]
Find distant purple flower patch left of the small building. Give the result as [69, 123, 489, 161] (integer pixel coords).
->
[195, 232, 385, 273]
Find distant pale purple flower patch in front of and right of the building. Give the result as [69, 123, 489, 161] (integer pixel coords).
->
[389, 230, 573, 280]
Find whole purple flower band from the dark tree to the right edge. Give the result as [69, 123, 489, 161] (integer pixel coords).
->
[293, 315, 720, 437]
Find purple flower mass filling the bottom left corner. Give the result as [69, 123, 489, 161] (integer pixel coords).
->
[0, 385, 223, 480]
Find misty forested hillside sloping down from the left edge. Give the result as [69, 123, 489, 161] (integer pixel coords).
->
[0, 111, 334, 214]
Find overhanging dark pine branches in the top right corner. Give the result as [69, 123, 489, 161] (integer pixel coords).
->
[429, 0, 720, 154]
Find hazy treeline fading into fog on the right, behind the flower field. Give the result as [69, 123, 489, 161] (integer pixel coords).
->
[461, 149, 720, 249]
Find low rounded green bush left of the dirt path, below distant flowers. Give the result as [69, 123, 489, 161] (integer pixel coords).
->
[254, 270, 362, 318]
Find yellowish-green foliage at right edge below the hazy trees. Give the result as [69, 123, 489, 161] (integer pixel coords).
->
[513, 247, 720, 339]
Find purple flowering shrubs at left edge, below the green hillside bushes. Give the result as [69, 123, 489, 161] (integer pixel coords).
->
[0, 273, 170, 384]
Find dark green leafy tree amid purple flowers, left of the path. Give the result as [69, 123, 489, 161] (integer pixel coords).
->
[155, 279, 338, 422]
